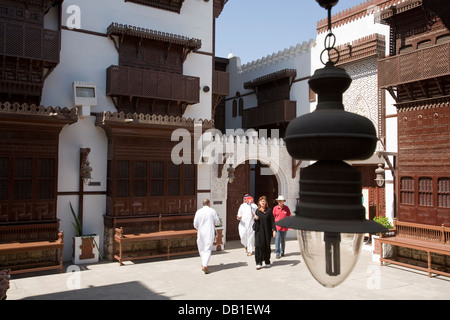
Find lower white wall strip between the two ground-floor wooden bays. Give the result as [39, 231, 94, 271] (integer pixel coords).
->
[57, 117, 108, 260]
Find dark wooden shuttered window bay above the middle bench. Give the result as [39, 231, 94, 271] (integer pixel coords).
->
[107, 155, 197, 216]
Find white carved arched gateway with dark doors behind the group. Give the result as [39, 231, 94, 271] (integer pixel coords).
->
[207, 135, 299, 244]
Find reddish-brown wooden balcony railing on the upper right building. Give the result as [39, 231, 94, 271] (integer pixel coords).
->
[378, 42, 450, 88]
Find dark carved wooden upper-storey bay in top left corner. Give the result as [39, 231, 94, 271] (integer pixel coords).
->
[0, 0, 61, 104]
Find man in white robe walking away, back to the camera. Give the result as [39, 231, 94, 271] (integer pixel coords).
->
[194, 199, 220, 274]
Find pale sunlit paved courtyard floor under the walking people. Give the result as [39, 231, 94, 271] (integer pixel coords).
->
[4, 239, 450, 303]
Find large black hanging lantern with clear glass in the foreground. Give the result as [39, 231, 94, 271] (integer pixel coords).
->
[277, 0, 387, 287]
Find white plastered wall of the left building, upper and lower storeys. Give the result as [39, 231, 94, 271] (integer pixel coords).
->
[41, 0, 214, 260]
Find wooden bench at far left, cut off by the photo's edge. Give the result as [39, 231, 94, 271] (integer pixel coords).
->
[0, 220, 64, 274]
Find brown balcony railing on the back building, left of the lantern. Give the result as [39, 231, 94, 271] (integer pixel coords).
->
[242, 100, 297, 128]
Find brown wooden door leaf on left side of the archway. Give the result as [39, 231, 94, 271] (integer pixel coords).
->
[226, 162, 250, 241]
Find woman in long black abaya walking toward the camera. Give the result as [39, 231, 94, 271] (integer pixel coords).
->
[253, 196, 276, 270]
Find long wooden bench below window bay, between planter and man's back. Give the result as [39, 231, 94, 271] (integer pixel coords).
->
[114, 214, 197, 265]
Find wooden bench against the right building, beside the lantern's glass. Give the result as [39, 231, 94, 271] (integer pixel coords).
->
[379, 220, 450, 277]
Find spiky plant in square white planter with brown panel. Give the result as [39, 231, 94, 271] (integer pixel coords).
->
[69, 203, 102, 264]
